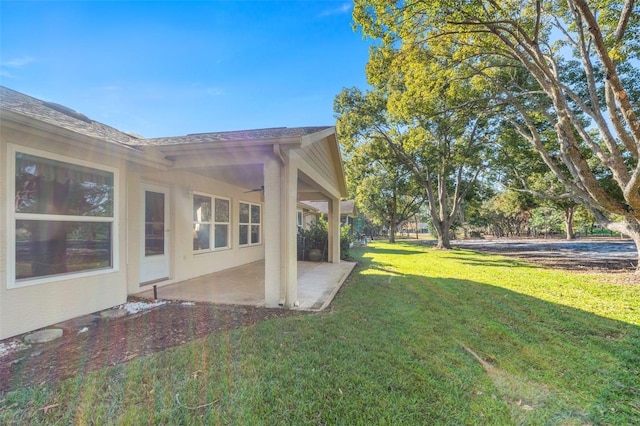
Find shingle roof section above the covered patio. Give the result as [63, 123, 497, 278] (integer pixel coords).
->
[139, 126, 331, 146]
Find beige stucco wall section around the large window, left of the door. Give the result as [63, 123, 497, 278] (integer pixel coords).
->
[0, 125, 127, 338]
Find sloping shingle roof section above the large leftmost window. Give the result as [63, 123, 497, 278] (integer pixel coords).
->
[0, 86, 138, 146]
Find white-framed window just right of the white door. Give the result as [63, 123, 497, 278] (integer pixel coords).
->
[193, 194, 231, 252]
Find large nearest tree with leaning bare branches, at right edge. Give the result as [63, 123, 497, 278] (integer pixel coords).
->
[354, 0, 640, 266]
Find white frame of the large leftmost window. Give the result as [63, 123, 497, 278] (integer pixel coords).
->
[6, 144, 120, 289]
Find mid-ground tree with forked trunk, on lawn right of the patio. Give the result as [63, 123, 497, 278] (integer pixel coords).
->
[334, 85, 488, 249]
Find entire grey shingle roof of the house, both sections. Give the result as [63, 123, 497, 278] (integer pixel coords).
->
[0, 86, 331, 147]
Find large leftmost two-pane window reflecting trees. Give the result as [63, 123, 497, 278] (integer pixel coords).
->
[9, 150, 115, 286]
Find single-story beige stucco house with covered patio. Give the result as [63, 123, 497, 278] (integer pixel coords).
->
[0, 86, 346, 339]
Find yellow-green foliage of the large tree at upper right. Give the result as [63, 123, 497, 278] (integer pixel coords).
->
[353, 0, 640, 250]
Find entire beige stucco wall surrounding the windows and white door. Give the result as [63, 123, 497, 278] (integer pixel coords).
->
[0, 120, 265, 339]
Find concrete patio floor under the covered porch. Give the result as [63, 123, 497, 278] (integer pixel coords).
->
[135, 261, 356, 311]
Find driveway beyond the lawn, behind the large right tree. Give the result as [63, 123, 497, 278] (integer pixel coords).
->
[452, 237, 638, 272]
